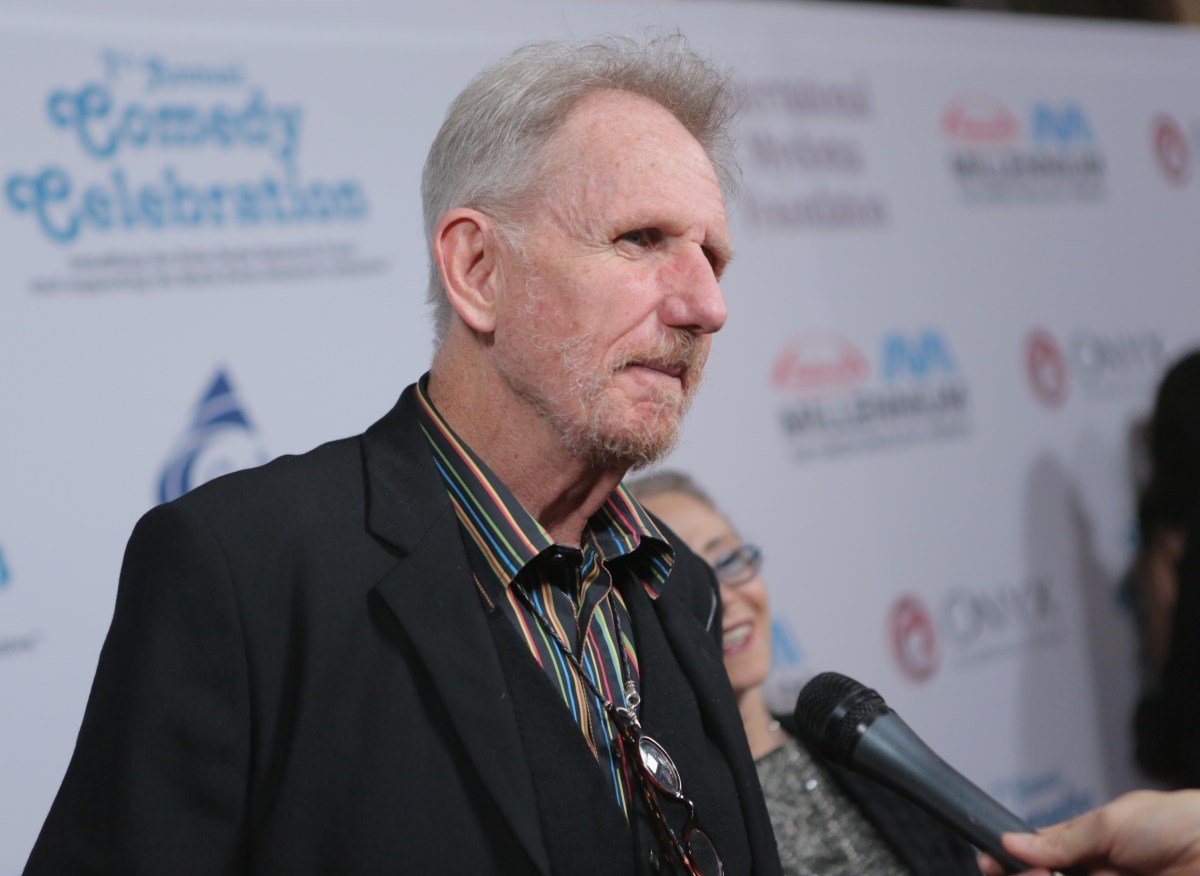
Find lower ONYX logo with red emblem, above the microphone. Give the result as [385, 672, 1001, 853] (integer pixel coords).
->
[887, 577, 1063, 683]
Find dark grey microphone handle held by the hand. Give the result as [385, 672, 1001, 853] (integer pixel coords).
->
[847, 712, 1084, 876]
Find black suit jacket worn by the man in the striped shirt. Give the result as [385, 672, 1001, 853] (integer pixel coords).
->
[26, 388, 778, 876]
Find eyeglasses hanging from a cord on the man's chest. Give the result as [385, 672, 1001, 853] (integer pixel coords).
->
[616, 707, 725, 876]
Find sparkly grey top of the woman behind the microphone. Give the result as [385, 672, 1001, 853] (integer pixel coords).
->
[755, 737, 912, 876]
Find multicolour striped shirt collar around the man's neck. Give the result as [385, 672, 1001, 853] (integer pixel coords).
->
[416, 373, 674, 596]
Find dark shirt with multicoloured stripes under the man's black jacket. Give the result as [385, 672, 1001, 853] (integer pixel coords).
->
[416, 377, 674, 818]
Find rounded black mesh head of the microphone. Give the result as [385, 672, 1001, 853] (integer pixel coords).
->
[794, 672, 892, 766]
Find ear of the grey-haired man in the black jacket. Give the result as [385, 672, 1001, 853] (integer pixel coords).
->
[433, 206, 499, 334]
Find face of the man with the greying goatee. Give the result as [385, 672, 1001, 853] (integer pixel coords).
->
[494, 91, 732, 467]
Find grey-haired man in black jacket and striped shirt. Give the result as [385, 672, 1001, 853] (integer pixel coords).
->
[28, 38, 778, 874]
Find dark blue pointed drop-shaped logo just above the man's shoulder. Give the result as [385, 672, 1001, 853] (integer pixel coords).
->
[158, 371, 268, 502]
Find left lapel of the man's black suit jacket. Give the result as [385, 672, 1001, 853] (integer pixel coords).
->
[362, 386, 550, 874]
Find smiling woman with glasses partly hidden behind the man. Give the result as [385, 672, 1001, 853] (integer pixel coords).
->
[628, 472, 979, 876]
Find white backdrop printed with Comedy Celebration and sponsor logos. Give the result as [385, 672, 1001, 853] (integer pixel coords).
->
[0, 0, 1200, 872]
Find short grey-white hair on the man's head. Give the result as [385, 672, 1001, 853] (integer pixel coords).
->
[421, 32, 737, 346]
